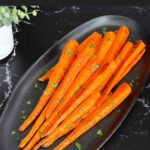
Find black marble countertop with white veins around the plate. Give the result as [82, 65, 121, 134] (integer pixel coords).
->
[0, 4, 150, 150]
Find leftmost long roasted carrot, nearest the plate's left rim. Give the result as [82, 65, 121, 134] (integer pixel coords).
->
[19, 40, 78, 131]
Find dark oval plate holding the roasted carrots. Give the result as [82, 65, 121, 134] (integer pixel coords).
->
[0, 15, 150, 150]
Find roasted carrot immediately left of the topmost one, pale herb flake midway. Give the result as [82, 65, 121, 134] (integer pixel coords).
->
[46, 32, 115, 120]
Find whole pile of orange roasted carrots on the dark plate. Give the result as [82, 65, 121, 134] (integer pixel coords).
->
[19, 26, 145, 150]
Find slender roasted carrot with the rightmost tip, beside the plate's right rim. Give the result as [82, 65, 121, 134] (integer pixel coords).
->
[98, 41, 145, 103]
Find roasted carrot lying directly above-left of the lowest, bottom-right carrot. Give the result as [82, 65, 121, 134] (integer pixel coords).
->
[33, 88, 101, 147]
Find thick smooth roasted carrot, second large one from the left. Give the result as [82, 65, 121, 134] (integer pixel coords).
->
[43, 32, 101, 119]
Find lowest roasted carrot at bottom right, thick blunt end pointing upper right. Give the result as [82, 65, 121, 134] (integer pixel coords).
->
[54, 83, 131, 150]
